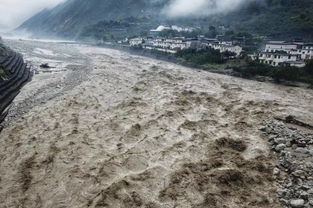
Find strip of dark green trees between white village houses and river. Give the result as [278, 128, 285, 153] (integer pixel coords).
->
[176, 49, 313, 86]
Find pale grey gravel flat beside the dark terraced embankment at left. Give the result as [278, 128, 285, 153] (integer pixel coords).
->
[2, 38, 93, 127]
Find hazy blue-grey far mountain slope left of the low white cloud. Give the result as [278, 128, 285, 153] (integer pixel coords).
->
[17, 0, 166, 37]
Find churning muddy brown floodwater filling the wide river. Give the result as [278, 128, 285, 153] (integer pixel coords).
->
[0, 41, 313, 208]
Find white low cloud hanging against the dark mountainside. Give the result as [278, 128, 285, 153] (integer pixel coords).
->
[163, 0, 249, 18]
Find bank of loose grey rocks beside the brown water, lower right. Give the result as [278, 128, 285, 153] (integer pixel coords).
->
[262, 117, 313, 208]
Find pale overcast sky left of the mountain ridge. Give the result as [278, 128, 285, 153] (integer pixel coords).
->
[0, 0, 64, 30]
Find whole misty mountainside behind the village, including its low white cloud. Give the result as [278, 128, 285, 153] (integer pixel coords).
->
[18, 0, 313, 39]
